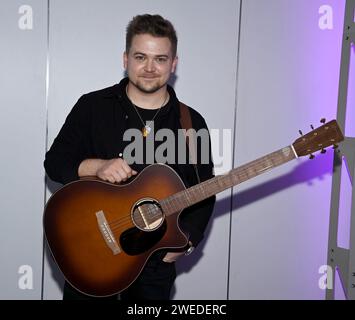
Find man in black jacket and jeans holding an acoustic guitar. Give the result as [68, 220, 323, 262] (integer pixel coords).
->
[44, 14, 215, 300]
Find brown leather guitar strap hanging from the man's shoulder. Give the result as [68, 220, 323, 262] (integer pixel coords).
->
[180, 102, 201, 183]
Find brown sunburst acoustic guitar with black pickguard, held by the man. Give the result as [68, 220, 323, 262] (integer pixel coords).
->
[43, 120, 344, 296]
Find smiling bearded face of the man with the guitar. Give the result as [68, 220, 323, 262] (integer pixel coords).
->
[123, 34, 177, 93]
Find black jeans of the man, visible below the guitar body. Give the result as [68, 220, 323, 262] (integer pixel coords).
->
[63, 255, 176, 301]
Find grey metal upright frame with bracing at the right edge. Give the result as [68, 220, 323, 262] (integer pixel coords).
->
[326, 0, 355, 300]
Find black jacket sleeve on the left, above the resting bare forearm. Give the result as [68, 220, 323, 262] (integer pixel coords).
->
[44, 95, 90, 184]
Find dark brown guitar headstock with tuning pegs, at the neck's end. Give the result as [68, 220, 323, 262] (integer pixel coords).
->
[292, 119, 344, 159]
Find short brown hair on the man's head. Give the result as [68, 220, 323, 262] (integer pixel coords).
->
[126, 14, 177, 57]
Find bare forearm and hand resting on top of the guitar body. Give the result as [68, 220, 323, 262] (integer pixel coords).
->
[78, 158, 137, 183]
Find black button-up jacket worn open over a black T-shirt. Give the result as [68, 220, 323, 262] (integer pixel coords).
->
[44, 79, 215, 246]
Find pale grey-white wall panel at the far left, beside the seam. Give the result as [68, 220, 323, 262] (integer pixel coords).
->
[0, 0, 47, 299]
